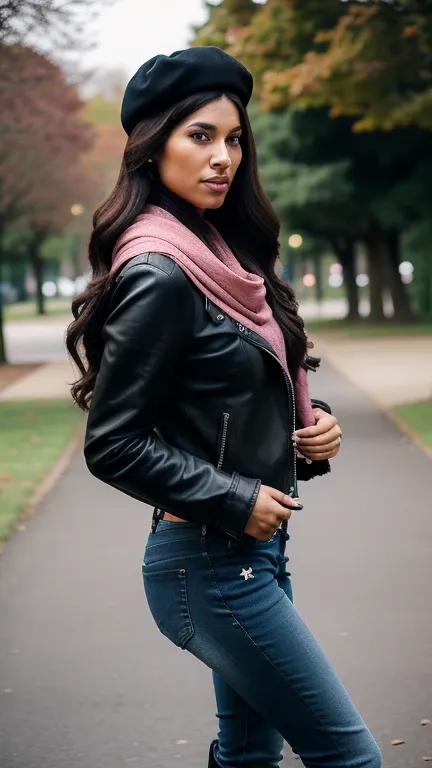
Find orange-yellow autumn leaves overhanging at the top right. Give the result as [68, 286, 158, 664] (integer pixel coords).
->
[203, 0, 432, 131]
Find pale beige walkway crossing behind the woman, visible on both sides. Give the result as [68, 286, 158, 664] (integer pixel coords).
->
[0, 333, 432, 408]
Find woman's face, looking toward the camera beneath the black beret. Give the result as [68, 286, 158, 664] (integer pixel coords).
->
[158, 96, 242, 216]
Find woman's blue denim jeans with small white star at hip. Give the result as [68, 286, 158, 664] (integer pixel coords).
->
[143, 520, 381, 768]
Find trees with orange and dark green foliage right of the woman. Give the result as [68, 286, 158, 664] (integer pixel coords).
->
[194, 0, 432, 322]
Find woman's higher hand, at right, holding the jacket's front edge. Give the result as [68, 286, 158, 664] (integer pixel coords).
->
[294, 408, 342, 461]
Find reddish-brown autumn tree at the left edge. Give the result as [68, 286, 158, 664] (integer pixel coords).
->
[0, 0, 115, 363]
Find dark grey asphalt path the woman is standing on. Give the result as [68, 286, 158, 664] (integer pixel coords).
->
[0, 350, 432, 768]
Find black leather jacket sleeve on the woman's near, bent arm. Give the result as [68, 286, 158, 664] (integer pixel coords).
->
[84, 257, 260, 539]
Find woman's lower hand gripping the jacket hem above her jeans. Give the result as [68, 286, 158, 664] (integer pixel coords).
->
[244, 485, 303, 541]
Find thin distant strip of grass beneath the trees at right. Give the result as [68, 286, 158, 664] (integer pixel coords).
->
[305, 319, 432, 339]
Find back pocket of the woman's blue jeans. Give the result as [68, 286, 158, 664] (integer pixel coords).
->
[142, 565, 194, 648]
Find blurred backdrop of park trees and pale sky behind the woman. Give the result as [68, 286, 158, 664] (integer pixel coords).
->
[0, 0, 432, 340]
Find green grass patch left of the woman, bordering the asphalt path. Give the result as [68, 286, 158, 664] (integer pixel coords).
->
[0, 400, 82, 541]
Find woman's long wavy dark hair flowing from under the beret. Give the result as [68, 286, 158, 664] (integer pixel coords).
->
[66, 92, 307, 410]
